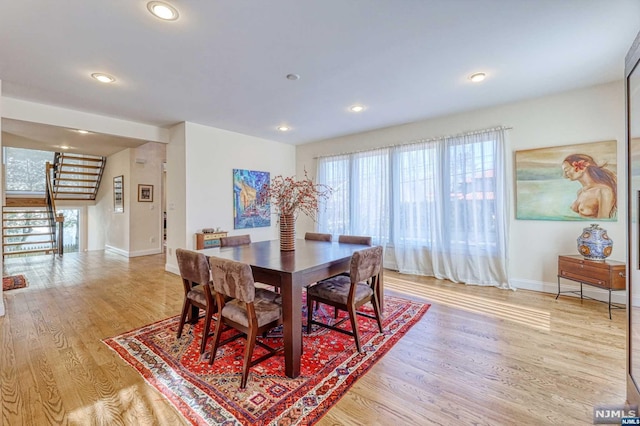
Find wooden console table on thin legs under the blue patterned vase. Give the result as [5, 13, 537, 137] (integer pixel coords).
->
[556, 255, 626, 319]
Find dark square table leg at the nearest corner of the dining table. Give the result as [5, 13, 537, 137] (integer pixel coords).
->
[281, 276, 302, 378]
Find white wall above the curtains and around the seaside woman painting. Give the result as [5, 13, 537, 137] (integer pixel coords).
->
[296, 81, 626, 299]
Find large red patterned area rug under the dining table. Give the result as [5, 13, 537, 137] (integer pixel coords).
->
[104, 295, 430, 425]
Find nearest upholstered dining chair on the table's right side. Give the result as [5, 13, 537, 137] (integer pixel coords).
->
[307, 246, 382, 352]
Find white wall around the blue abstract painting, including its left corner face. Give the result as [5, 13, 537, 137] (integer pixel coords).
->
[166, 123, 295, 273]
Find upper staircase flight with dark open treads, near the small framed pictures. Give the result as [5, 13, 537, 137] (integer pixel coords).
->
[52, 152, 107, 200]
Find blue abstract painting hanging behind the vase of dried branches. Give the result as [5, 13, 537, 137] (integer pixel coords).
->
[233, 169, 271, 229]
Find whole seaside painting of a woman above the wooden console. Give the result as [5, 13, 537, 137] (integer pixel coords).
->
[515, 141, 618, 221]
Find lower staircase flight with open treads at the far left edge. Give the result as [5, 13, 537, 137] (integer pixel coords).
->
[2, 205, 56, 257]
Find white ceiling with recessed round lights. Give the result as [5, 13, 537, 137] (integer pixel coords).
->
[0, 0, 640, 153]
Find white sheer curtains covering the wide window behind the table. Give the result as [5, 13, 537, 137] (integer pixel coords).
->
[317, 129, 509, 288]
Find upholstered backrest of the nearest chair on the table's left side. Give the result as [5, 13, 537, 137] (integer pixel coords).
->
[209, 256, 256, 303]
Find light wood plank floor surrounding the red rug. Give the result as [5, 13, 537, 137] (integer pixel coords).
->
[0, 252, 625, 426]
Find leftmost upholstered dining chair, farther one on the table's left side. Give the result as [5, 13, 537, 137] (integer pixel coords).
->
[176, 248, 216, 353]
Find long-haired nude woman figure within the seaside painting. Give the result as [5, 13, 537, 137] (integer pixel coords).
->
[562, 154, 618, 219]
